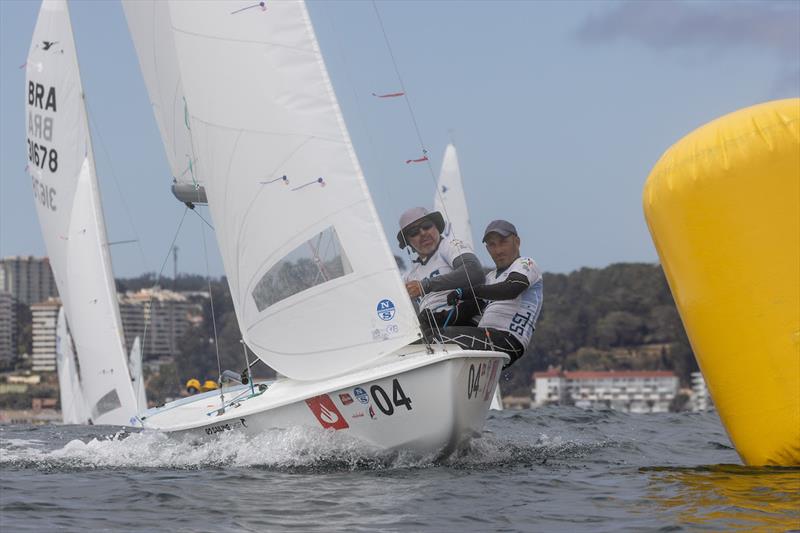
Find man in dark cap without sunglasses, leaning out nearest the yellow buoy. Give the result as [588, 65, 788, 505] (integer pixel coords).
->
[440, 220, 543, 367]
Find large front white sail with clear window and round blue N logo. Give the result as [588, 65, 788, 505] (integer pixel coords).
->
[125, 1, 419, 380]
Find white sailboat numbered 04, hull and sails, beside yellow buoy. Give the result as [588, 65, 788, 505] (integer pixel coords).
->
[116, 0, 507, 452]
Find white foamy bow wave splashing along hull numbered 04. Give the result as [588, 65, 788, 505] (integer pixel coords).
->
[0, 420, 602, 470]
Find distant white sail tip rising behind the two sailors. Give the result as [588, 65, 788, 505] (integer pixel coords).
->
[433, 144, 475, 250]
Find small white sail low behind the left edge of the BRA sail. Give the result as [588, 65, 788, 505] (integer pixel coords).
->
[56, 307, 89, 424]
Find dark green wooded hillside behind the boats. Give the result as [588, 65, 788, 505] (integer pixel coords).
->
[118, 263, 697, 398]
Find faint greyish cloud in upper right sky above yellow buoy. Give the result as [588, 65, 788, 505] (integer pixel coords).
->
[577, 1, 800, 61]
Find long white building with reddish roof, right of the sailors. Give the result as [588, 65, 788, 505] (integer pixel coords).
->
[532, 369, 678, 413]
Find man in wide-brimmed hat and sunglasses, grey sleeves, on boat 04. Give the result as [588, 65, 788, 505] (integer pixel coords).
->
[397, 207, 483, 329]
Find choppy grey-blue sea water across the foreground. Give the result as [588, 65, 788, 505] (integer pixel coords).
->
[0, 407, 800, 532]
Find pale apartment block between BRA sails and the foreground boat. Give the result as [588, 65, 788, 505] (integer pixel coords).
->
[119, 289, 202, 359]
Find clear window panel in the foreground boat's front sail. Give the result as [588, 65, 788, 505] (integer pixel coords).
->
[253, 226, 353, 311]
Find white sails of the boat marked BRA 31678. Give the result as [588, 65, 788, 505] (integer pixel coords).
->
[26, 0, 136, 425]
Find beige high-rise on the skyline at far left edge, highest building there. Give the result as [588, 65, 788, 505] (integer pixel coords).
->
[0, 256, 58, 305]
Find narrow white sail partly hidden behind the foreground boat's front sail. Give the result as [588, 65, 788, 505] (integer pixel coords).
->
[122, 0, 202, 196]
